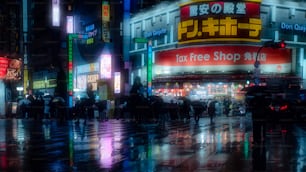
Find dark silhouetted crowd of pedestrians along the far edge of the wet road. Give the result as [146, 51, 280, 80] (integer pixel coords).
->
[11, 77, 246, 123]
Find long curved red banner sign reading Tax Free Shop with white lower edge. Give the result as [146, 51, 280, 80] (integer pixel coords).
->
[154, 45, 292, 74]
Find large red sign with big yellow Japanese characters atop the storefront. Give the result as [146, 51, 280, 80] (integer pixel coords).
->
[178, 0, 262, 44]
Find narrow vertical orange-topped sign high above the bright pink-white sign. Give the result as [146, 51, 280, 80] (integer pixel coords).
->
[101, 1, 110, 42]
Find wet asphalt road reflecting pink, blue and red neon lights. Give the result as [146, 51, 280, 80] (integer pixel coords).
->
[0, 116, 306, 172]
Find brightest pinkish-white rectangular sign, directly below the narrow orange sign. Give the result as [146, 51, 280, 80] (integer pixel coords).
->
[100, 54, 112, 79]
